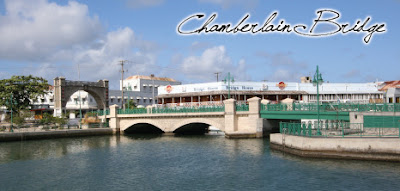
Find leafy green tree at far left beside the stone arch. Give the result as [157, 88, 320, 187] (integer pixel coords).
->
[0, 75, 49, 113]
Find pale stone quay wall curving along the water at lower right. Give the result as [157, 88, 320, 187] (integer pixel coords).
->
[270, 133, 400, 162]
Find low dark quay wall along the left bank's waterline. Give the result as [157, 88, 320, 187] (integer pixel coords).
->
[0, 128, 114, 142]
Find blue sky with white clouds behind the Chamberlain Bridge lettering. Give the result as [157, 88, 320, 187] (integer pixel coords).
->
[0, 0, 400, 89]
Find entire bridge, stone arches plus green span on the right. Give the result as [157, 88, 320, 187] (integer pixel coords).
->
[98, 97, 400, 137]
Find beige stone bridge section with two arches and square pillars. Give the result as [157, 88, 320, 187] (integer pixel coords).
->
[106, 97, 265, 137]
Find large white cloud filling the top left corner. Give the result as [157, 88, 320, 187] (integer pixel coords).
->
[0, 0, 102, 60]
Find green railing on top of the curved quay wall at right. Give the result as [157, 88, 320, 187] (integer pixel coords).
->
[279, 121, 400, 138]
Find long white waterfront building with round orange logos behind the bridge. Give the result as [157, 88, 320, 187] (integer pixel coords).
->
[157, 79, 384, 105]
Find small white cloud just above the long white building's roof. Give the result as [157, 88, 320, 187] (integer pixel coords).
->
[180, 46, 247, 81]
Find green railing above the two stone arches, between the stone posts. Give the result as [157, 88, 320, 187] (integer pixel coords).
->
[152, 106, 225, 113]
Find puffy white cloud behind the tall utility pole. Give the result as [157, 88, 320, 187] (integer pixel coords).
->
[74, 27, 157, 88]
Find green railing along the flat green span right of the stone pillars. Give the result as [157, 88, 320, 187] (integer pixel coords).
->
[261, 103, 400, 112]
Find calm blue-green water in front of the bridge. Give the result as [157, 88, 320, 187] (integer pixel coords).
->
[0, 136, 400, 191]
